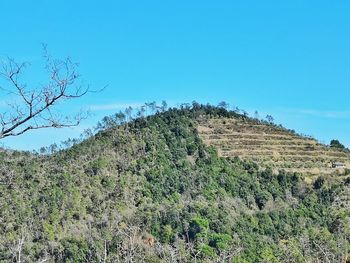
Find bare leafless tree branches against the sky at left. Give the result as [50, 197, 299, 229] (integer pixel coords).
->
[0, 47, 91, 139]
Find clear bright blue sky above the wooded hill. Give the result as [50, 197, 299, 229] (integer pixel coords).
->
[0, 0, 350, 149]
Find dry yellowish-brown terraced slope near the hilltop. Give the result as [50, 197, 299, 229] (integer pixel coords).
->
[198, 118, 350, 175]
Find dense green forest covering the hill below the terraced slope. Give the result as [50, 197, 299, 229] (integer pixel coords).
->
[0, 103, 350, 262]
